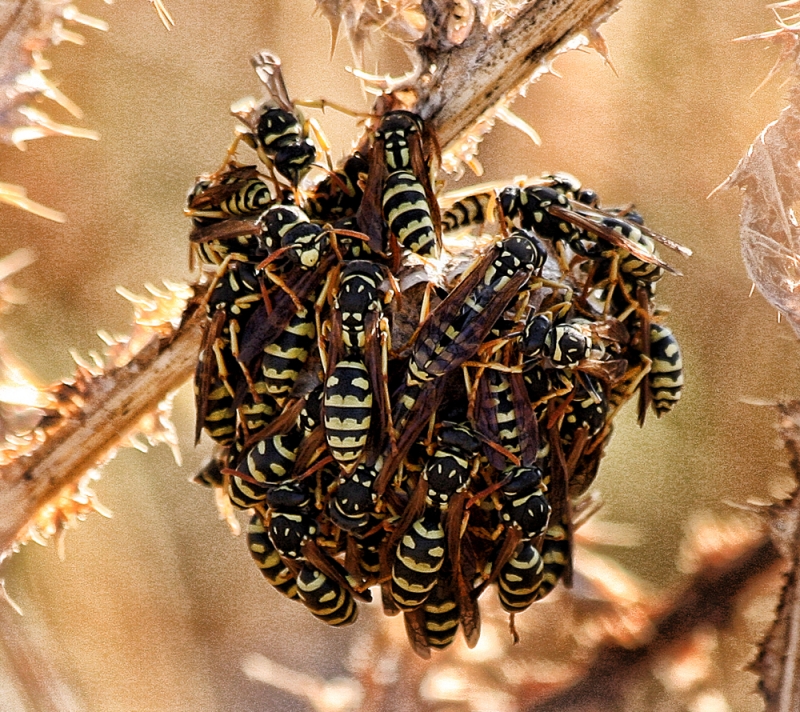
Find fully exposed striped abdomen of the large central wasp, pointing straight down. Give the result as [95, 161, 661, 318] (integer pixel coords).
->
[323, 359, 372, 472]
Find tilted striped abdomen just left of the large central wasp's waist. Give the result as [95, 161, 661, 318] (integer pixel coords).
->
[261, 309, 317, 398]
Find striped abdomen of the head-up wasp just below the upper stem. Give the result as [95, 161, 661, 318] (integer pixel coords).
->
[383, 171, 437, 257]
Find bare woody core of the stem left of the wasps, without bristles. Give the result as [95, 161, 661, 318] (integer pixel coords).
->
[0, 310, 205, 554]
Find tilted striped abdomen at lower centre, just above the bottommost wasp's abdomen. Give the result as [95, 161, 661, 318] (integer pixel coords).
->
[392, 507, 445, 610]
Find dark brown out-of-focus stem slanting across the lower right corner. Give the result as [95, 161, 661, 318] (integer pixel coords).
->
[528, 536, 780, 712]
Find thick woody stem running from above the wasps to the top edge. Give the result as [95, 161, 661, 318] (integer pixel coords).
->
[416, 0, 619, 146]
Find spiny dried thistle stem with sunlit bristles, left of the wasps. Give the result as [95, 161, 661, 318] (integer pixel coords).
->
[0, 283, 200, 553]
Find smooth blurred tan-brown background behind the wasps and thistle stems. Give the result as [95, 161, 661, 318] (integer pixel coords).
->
[0, 0, 800, 712]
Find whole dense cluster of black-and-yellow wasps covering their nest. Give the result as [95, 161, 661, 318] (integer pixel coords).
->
[187, 53, 682, 654]
